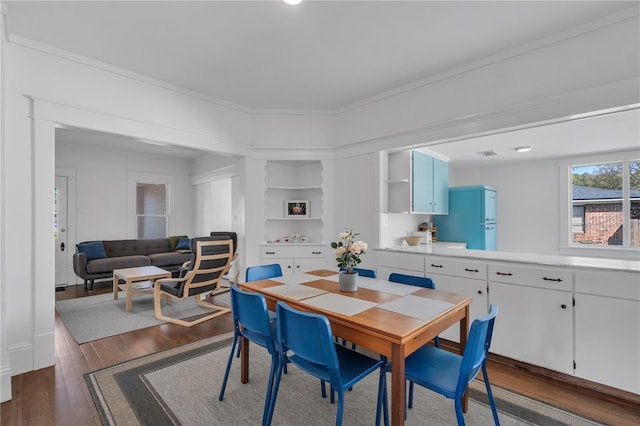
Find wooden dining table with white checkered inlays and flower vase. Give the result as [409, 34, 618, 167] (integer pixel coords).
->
[239, 269, 471, 426]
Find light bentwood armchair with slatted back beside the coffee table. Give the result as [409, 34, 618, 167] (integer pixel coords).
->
[153, 237, 237, 327]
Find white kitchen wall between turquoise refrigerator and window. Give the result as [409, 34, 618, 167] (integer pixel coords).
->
[449, 160, 560, 255]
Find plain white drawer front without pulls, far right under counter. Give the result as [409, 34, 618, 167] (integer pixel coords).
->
[576, 270, 640, 300]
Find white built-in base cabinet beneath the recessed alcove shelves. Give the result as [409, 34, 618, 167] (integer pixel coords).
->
[260, 244, 330, 276]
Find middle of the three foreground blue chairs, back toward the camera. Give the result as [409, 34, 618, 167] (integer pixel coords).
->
[268, 302, 387, 426]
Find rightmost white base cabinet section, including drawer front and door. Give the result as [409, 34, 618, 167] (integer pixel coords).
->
[575, 271, 640, 394]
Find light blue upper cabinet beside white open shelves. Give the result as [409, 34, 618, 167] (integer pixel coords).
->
[411, 150, 449, 214]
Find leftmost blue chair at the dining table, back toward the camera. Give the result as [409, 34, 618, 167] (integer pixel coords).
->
[218, 286, 278, 425]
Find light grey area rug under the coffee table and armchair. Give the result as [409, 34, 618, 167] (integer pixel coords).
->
[56, 292, 228, 344]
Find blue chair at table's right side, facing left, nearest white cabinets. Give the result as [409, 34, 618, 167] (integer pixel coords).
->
[376, 304, 500, 426]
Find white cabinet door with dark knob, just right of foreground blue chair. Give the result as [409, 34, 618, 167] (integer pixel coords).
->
[489, 282, 573, 374]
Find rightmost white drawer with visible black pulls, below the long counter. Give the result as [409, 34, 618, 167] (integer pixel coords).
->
[489, 263, 573, 291]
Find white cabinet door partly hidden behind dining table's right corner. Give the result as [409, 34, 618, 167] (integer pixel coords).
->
[427, 274, 488, 343]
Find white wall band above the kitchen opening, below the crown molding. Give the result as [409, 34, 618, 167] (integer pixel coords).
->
[335, 9, 640, 149]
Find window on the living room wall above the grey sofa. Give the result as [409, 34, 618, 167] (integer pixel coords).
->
[136, 183, 169, 239]
